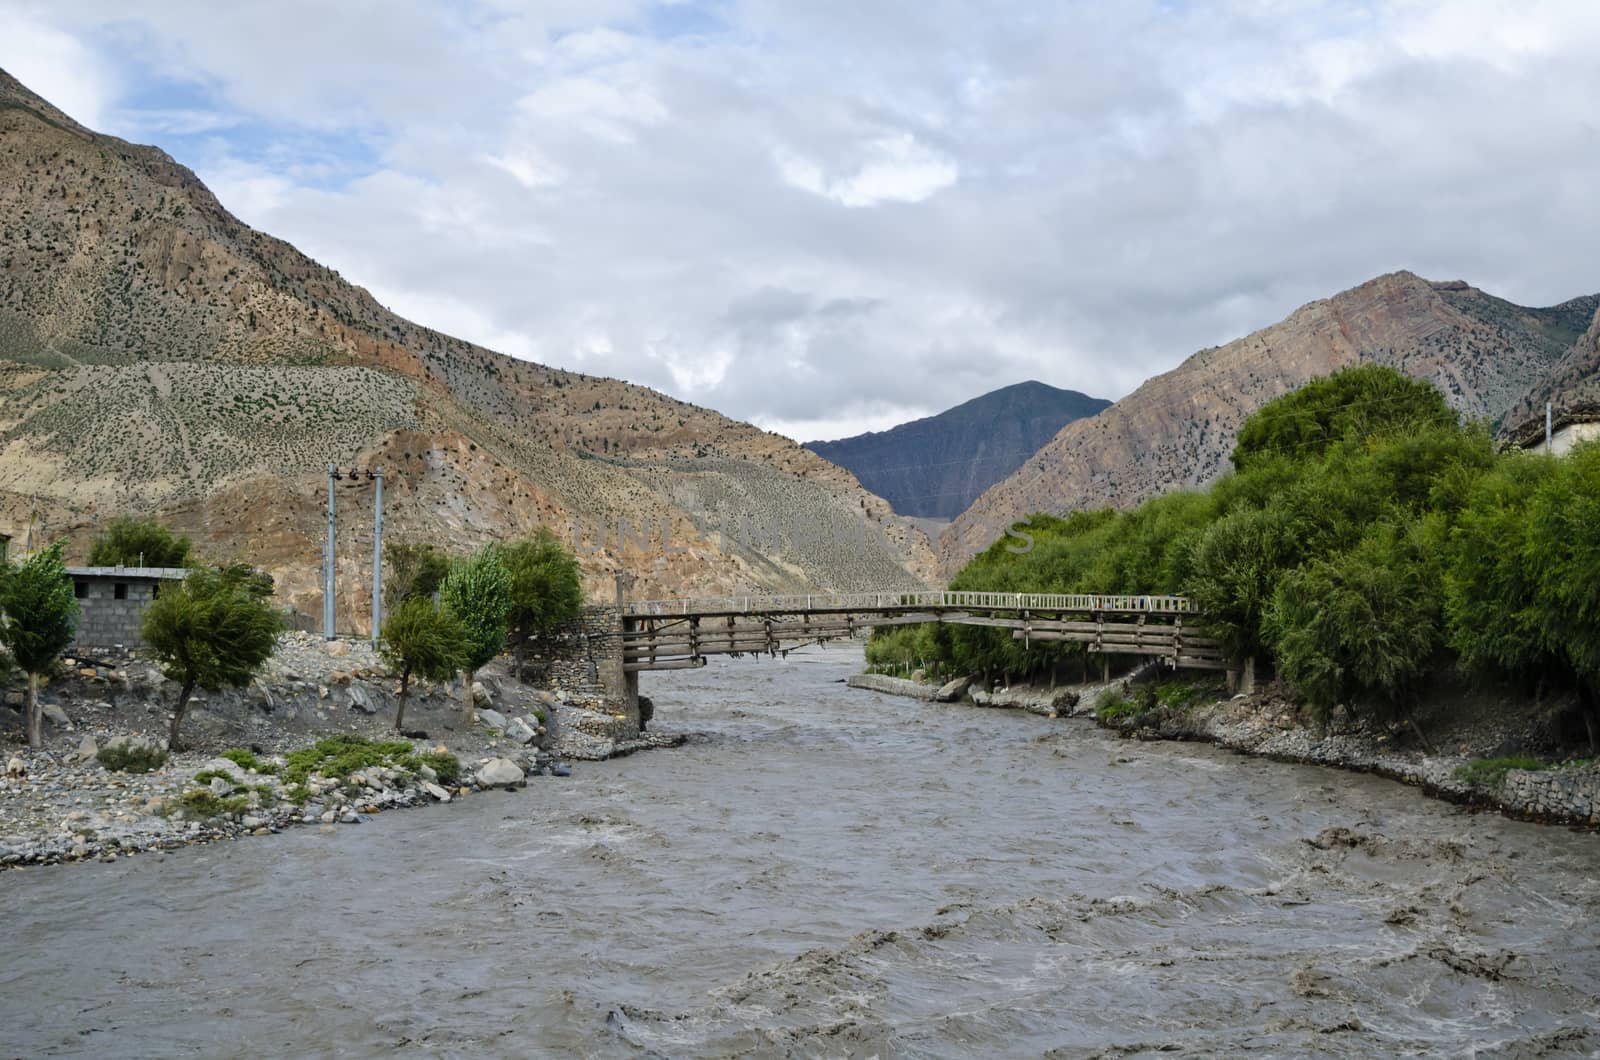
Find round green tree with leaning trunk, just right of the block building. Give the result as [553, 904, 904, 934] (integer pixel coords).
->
[144, 565, 283, 751]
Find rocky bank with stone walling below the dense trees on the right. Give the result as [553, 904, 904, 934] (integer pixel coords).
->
[850, 677, 1600, 826]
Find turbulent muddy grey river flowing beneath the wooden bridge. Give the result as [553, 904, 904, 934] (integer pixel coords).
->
[0, 647, 1600, 1057]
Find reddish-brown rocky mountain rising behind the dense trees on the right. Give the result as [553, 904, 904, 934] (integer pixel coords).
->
[939, 272, 1600, 576]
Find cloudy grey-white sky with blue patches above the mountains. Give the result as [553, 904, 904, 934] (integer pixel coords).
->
[0, 0, 1600, 440]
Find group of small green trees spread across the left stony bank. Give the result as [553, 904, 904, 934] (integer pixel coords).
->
[0, 517, 582, 749]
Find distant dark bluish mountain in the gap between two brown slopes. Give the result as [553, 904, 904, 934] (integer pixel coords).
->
[805, 381, 1110, 519]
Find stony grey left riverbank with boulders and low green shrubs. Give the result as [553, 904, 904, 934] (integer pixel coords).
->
[0, 634, 682, 869]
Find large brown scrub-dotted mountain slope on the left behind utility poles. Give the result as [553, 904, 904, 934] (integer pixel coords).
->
[0, 70, 933, 626]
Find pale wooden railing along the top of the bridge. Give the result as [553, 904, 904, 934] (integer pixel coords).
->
[622, 589, 1197, 616]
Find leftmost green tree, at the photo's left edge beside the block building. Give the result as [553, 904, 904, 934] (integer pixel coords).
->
[0, 541, 78, 748]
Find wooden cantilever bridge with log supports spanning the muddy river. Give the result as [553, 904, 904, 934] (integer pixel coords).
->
[619, 591, 1227, 681]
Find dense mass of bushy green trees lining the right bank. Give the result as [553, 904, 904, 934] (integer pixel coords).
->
[869, 365, 1600, 749]
